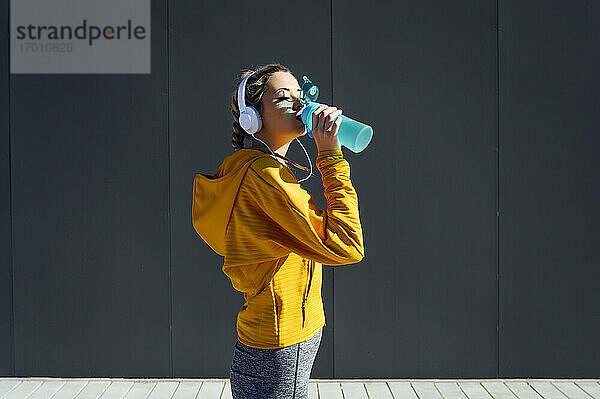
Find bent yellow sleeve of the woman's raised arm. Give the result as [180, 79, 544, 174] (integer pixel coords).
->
[238, 150, 365, 265]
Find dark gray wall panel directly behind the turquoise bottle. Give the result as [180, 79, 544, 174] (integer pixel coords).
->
[333, 1, 498, 378]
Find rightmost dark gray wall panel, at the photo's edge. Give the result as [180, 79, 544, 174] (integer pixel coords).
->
[498, 1, 600, 378]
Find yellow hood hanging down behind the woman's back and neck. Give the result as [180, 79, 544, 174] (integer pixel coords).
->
[192, 149, 270, 256]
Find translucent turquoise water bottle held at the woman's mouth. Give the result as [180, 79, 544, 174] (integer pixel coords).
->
[300, 101, 373, 153]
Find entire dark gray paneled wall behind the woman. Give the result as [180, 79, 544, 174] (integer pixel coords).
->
[0, 0, 600, 378]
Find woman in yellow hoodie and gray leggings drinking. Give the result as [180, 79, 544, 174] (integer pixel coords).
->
[192, 64, 364, 399]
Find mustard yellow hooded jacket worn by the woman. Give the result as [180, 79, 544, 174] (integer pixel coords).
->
[192, 149, 365, 349]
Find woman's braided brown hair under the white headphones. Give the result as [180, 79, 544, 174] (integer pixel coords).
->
[231, 64, 292, 151]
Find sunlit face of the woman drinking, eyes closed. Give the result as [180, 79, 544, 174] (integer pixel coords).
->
[260, 72, 306, 141]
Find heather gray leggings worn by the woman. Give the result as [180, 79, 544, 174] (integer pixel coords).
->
[229, 328, 323, 399]
